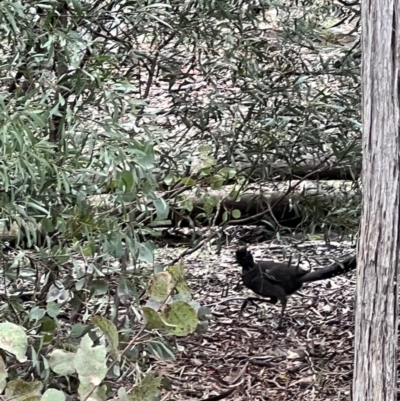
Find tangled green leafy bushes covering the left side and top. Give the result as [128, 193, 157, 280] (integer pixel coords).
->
[0, 0, 361, 400]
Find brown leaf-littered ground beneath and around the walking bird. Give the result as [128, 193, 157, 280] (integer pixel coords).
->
[157, 239, 355, 401]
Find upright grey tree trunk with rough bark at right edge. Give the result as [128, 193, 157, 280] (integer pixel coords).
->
[353, 0, 400, 401]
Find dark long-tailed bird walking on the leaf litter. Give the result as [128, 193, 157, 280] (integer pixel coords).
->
[236, 247, 357, 327]
